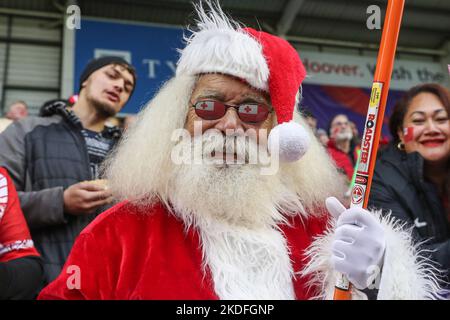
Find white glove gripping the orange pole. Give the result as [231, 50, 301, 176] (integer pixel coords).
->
[325, 197, 386, 289]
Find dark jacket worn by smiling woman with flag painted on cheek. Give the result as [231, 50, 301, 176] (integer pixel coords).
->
[369, 144, 450, 281]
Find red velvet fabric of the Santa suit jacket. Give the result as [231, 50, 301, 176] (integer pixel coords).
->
[39, 203, 326, 300]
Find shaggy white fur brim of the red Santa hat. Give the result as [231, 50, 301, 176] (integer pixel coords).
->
[176, 3, 269, 91]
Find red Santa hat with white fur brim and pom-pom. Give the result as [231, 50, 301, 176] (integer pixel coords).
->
[176, 3, 310, 162]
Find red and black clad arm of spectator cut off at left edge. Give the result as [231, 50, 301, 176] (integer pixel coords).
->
[0, 167, 43, 300]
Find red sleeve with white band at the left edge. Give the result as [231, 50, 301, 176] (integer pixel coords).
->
[0, 167, 39, 263]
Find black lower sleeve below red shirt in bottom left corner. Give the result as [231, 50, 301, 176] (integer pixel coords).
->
[0, 257, 43, 300]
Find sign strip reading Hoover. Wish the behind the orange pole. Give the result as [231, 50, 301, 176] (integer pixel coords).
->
[300, 51, 447, 90]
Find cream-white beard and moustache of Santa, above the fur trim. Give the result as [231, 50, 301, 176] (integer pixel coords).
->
[168, 133, 302, 229]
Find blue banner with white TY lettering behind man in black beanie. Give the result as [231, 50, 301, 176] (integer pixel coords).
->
[74, 19, 183, 114]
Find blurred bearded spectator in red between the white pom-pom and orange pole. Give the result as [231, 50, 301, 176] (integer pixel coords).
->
[327, 114, 355, 182]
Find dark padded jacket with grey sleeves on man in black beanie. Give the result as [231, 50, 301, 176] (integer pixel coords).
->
[0, 102, 120, 282]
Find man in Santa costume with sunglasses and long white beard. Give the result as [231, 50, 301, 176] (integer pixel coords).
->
[40, 4, 439, 299]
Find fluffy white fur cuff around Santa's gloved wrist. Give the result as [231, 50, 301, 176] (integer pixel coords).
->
[301, 211, 441, 300]
